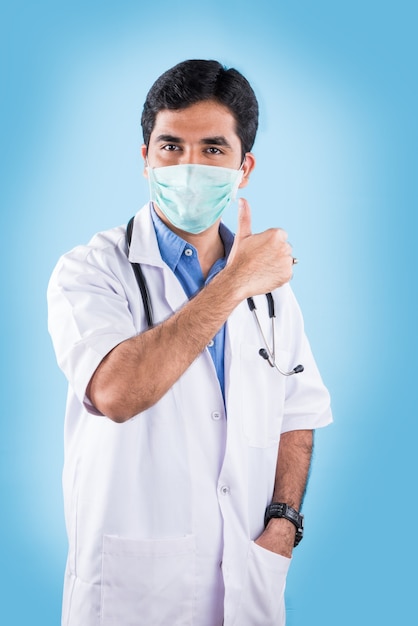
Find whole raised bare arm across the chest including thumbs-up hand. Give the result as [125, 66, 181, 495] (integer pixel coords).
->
[87, 200, 292, 422]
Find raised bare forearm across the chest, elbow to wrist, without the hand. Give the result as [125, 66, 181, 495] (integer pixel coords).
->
[87, 273, 245, 422]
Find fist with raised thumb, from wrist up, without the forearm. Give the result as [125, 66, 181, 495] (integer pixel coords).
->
[226, 198, 293, 299]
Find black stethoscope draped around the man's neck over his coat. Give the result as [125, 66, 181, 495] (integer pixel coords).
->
[126, 217, 304, 376]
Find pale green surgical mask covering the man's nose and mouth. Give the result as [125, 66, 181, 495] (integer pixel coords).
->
[147, 164, 243, 234]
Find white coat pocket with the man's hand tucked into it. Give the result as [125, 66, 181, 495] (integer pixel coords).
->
[235, 541, 291, 626]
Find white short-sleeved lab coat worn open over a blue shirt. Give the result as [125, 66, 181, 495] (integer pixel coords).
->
[48, 206, 331, 626]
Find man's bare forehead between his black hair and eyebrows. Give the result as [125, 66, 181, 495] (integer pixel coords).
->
[151, 100, 239, 141]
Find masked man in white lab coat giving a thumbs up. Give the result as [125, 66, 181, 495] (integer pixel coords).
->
[48, 61, 331, 626]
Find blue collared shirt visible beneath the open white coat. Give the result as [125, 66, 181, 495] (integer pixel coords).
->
[151, 205, 234, 398]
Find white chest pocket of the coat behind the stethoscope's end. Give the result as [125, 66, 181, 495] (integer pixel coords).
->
[240, 344, 289, 448]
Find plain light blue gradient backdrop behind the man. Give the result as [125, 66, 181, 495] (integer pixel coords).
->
[0, 0, 418, 626]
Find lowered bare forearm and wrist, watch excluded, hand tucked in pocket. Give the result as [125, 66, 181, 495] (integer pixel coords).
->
[256, 430, 313, 558]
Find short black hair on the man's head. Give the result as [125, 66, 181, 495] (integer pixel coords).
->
[141, 60, 258, 156]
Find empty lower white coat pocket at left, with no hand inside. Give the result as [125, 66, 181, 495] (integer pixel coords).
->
[100, 535, 195, 626]
